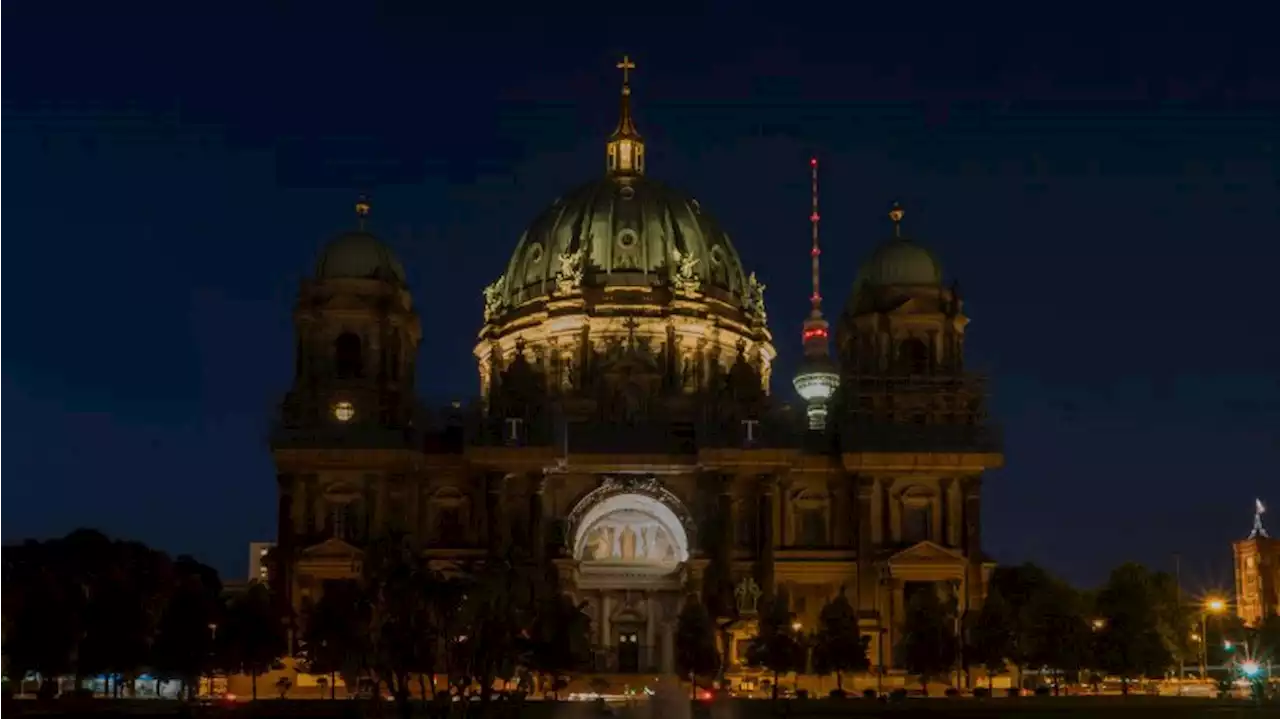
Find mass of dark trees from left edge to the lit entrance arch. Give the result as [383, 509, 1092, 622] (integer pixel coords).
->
[0, 530, 591, 715]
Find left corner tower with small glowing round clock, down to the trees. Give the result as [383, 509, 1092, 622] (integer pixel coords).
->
[271, 198, 421, 609]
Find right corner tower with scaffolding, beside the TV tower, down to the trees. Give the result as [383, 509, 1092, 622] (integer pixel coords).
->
[837, 203, 1004, 656]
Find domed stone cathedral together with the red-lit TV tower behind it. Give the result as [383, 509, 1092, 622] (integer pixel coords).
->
[271, 59, 1004, 676]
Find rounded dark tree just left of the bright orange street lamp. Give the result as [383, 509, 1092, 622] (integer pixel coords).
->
[1094, 563, 1174, 695]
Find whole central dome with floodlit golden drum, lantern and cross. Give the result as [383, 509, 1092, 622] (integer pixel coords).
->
[475, 58, 776, 402]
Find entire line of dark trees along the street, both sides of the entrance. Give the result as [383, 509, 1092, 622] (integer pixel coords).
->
[0, 530, 1280, 715]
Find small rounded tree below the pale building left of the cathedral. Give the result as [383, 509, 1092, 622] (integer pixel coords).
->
[216, 582, 288, 701]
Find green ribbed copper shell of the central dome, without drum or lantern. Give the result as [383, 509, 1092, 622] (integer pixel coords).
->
[488, 175, 749, 310]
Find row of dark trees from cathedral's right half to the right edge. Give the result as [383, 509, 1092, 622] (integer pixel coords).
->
[732, 563, 1280, 696]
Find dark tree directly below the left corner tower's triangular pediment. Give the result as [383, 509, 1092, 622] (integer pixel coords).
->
[298, 581, 366, 699]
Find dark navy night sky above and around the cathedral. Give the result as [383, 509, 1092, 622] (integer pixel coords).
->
[0, 0, 1280, 587]
